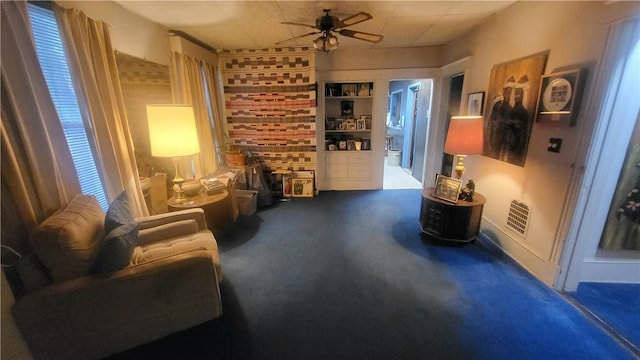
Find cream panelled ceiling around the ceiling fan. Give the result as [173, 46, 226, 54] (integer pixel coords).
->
[115, 0, 515, 49]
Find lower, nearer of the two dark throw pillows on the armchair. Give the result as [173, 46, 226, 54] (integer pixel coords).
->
[91, 223, 138, 273]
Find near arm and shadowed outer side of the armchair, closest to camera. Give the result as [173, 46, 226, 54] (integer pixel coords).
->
[12, 250, 222, 359]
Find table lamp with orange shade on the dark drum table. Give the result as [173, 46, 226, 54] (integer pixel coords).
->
[444, 116, 483, 179]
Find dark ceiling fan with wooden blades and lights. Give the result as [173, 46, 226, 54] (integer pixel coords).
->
[276, 9, 383, 52]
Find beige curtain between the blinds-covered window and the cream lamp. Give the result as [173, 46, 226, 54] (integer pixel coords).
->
[56, 7, 149, 216]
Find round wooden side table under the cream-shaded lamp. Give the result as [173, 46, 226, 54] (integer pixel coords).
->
[167, 190, 233, 235]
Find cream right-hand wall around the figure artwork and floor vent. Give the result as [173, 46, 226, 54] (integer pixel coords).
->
[445, 1, 638, 285]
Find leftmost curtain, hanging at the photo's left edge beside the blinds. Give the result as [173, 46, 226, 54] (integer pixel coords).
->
[0, 1, 81, 228]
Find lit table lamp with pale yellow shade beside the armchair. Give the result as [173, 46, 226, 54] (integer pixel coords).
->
[147, 105, 200, 204]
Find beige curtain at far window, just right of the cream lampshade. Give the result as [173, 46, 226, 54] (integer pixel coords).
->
[170, 52, 226, 177]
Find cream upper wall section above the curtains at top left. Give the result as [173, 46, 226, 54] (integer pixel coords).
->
[56, 0, 170, 65]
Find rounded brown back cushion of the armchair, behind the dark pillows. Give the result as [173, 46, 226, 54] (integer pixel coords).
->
[29, 195, 104, 281]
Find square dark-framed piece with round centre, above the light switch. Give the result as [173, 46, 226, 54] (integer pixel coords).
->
[535, 69, 585, 126]
